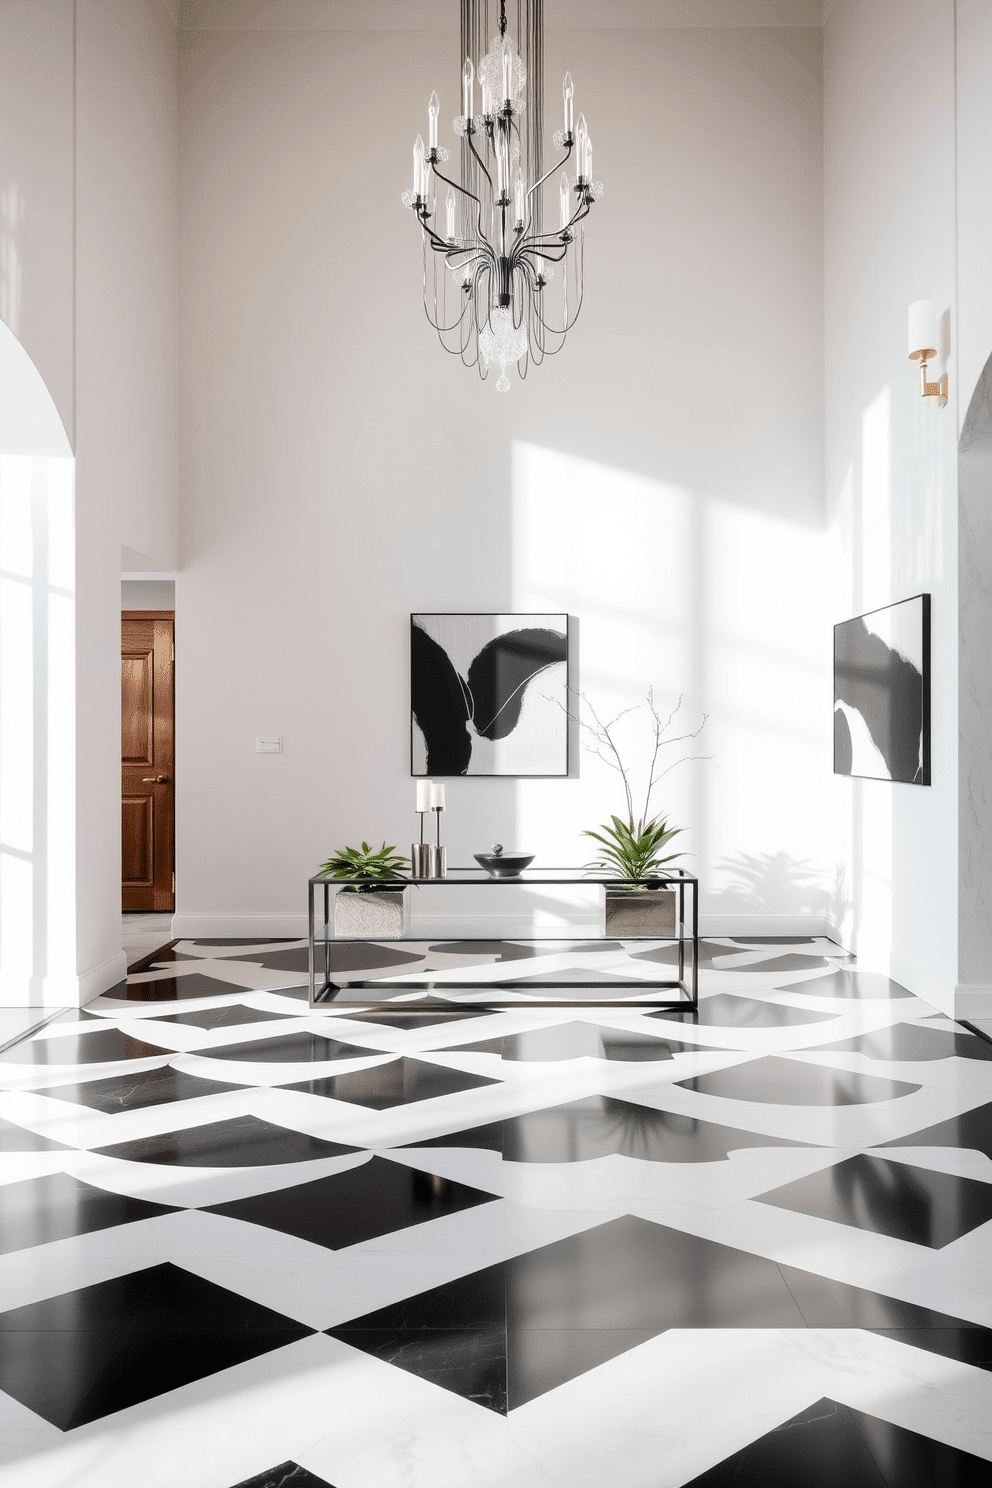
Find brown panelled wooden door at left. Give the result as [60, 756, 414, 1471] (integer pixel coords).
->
[120, 610, 175, 912]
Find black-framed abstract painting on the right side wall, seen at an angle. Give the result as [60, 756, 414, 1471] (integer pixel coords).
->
[833, 594, 930, 786]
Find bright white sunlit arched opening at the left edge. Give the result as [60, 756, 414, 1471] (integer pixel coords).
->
[0, 323, 79, 1007]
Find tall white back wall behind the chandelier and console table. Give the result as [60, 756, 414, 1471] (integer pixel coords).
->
[175, 3, 834, 933]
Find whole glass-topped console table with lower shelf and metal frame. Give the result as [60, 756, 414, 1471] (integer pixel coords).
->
[308, 868, 699, 1010]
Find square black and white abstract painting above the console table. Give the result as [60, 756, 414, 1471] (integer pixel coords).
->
[410, 615, 568, 775]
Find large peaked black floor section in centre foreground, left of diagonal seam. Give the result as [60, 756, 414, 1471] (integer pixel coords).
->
[329, 1216, 803, 1411]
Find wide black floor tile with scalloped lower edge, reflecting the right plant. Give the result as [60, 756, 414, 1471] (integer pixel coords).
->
[409, 1092, 802, 1162]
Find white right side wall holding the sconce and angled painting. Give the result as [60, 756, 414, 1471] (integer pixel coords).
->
[824, 0, 959, 1012]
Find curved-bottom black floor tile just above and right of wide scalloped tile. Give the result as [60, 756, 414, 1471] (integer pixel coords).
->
[675, 1055, 921, 1106]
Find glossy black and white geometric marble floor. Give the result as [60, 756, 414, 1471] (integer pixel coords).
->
[0, 940, 992, 1488]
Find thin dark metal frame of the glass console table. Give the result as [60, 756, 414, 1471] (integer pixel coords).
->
[308, 868, 699, 1012]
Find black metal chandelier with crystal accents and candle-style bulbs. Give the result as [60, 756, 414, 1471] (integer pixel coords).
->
[403, 0, 602, 393]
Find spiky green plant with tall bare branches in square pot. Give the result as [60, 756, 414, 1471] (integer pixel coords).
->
[574, 689, 706, 939]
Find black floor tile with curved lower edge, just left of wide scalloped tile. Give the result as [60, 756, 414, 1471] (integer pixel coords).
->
[98, 1116, 357, 1168]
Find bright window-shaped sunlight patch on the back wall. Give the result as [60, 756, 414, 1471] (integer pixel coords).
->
[512, 442, 833, 915]
